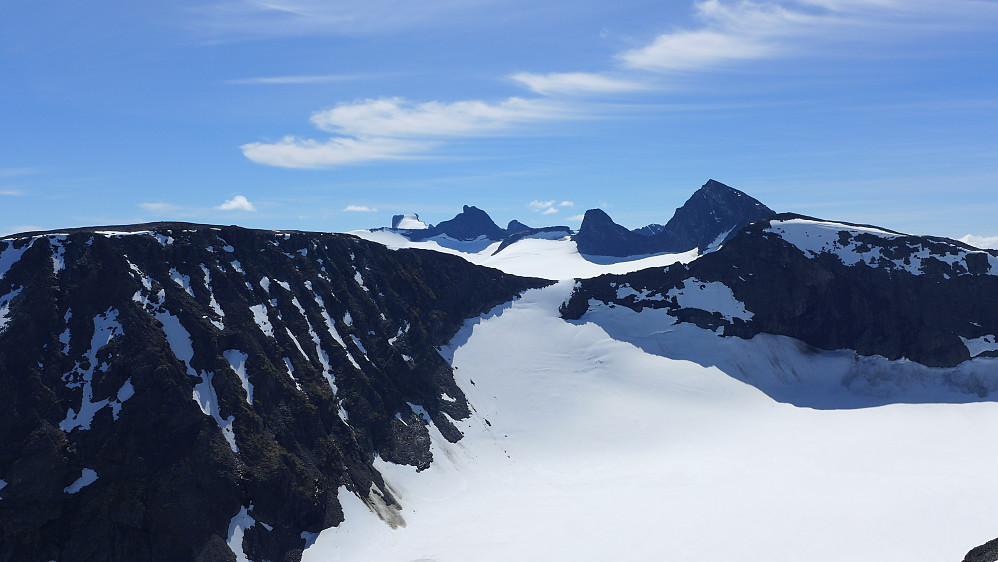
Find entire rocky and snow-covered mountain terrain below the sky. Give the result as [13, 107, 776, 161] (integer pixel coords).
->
[0, 182, 998, 562]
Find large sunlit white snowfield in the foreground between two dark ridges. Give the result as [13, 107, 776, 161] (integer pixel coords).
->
[304, 284, 998, 562]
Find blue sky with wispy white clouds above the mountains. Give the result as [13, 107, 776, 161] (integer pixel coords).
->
[0, 0, 998, 237]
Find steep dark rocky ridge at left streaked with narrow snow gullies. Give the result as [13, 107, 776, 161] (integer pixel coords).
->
[0, 224, 542, 561]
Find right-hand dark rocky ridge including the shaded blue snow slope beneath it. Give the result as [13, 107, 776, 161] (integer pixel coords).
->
[562, 214, 998, 407]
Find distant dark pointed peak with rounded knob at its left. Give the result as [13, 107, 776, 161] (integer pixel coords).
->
[575, 180, 773, 257]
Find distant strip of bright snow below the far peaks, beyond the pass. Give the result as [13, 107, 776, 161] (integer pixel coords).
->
[350, 230, 697, 280]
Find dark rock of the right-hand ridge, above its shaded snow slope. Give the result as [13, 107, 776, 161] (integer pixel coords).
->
[562, 215, 998, 367]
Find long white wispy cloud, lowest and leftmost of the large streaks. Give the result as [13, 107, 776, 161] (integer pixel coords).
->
[240, 97, 571, 168]
